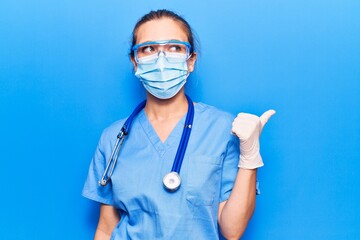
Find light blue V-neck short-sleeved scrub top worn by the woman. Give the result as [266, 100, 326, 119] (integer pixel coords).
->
[82, 103, 239, 240]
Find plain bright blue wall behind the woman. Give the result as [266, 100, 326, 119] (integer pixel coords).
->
[0, 0, 360, 240]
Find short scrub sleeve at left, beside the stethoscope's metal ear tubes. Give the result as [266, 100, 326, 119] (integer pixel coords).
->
[82, 131, 113, 205]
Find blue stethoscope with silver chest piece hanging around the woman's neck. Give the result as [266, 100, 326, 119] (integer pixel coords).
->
[99, 95, 194, 192]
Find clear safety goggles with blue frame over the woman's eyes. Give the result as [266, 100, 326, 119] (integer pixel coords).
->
[132, 40, 191, 64]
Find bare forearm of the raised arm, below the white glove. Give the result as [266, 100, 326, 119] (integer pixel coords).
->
[219, 168, 257, 239]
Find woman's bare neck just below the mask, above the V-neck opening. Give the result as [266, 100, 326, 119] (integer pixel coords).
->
[145, 90, 188, 121]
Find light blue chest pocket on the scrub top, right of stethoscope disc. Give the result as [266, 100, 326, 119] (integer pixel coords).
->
[186, 155, 221, 206]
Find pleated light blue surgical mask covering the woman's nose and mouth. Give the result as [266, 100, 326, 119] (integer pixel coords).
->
[135, 53, 189, 99]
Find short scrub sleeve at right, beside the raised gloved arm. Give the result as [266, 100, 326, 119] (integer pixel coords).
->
[220, 134, 240, 202]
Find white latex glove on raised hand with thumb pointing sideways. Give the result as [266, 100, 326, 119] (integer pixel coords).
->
[232, 110, 275, 169]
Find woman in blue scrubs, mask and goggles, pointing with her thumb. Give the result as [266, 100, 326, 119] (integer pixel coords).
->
[83, 10, 274, 240]
